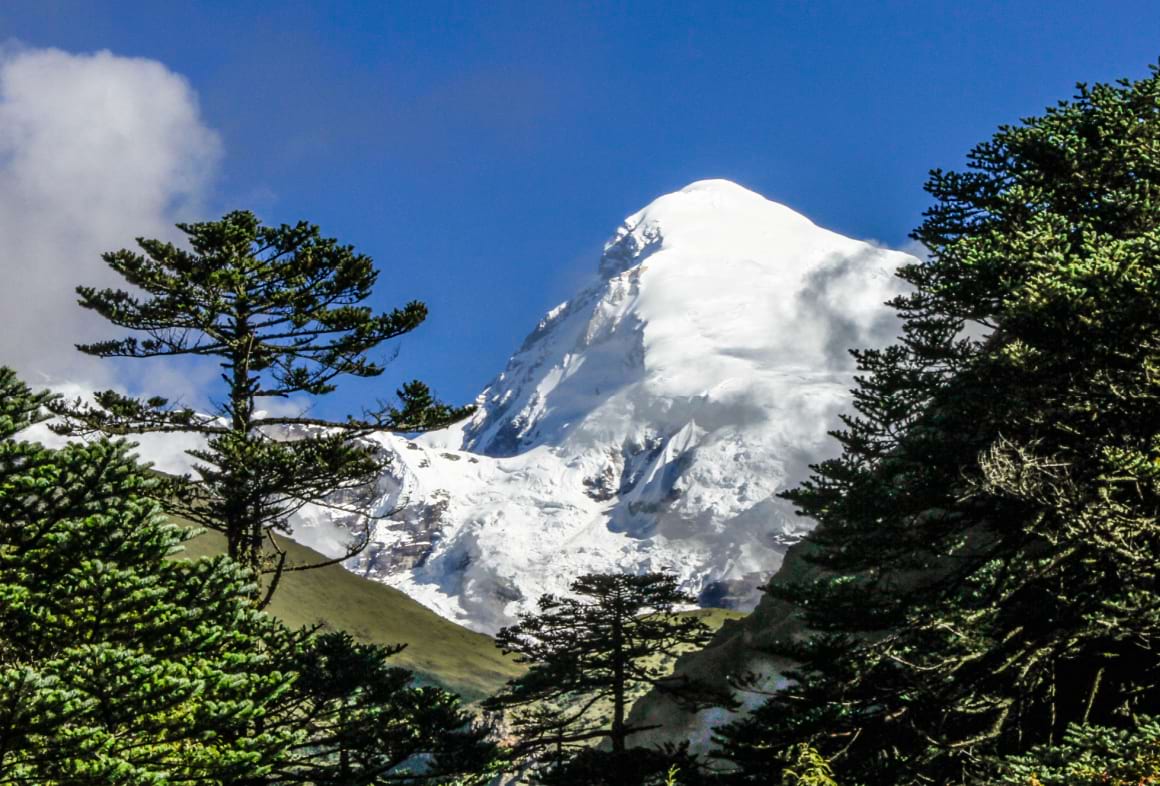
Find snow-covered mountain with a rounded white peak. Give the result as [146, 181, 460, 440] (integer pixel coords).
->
[296, 180, 911, 632]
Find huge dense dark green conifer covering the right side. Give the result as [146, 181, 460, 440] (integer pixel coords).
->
[722, 71, 1160, 784]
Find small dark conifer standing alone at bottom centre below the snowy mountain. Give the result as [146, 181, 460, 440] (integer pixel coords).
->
[484, 574, 722, 784]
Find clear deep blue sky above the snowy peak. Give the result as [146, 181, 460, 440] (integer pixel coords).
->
[0, 0, 1160, 409]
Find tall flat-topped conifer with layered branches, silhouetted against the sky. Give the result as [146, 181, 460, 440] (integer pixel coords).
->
[48, 212, 469, 605]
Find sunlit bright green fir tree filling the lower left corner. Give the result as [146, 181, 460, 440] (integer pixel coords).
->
[0, 369, 298, 785]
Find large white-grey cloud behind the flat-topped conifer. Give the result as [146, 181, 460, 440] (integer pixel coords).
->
[0, 46, 220, 393]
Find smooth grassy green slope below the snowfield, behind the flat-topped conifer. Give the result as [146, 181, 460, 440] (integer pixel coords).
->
[170, 531, 523, 701]
